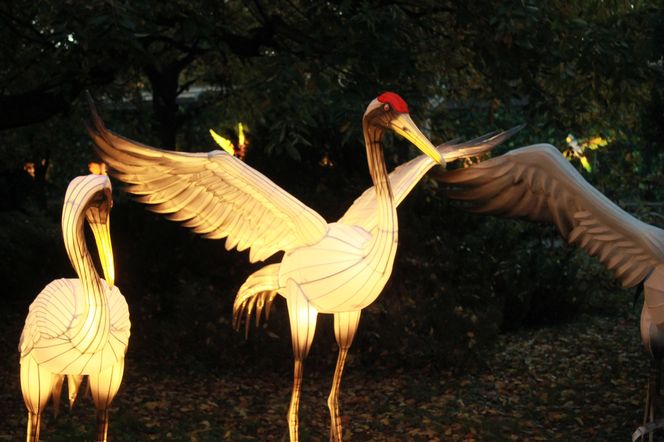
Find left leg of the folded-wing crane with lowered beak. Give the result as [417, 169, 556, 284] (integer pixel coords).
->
[21, 356, 56, 442]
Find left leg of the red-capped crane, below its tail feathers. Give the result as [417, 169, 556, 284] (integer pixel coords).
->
[286, 280, 318, 442]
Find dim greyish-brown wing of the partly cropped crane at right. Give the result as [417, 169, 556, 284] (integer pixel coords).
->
[438, 144, 664, 287]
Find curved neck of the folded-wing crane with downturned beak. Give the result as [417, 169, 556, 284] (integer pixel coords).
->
[62, 202, 110, 353]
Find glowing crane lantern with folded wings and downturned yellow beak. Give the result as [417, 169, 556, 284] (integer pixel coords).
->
[19, 175, 130, 442]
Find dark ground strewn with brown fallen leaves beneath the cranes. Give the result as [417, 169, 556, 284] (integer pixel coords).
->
[0, 312, 649, 441]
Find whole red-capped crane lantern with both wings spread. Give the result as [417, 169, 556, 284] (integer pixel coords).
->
[89, 92, 502, 441]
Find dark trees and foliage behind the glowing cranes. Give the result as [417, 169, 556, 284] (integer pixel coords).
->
[0, 0, 664, 440]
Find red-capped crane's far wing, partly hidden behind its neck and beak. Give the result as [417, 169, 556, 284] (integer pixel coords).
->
[339, 126, 523, 231]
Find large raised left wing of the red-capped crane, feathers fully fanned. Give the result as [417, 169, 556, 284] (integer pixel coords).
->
[88, 103, 327, 262]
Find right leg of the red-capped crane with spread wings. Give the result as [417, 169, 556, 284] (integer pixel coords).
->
[327, 310, 361, 442]
